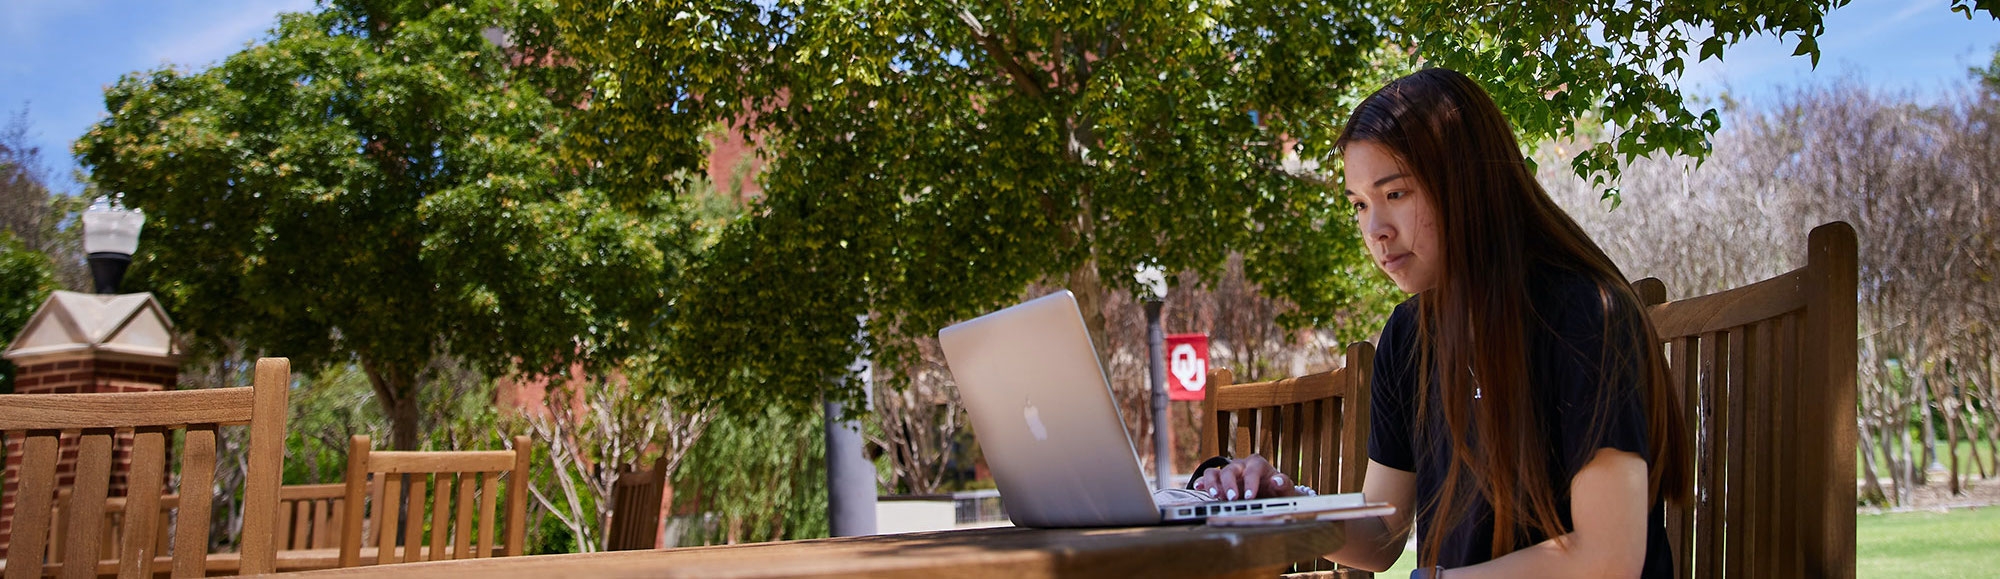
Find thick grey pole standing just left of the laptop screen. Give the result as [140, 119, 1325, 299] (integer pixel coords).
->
[824, 315, 876, 537]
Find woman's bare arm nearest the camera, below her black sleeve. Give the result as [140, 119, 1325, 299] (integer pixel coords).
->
[1448, 449, 1646, 579]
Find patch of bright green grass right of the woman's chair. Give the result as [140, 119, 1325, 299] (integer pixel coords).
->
[1856, 507, 2000, 577]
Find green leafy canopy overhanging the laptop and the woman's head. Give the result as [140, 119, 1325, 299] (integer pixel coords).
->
[544, 0, 1846, 409]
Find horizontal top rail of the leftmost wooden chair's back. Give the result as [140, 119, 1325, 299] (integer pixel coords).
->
[0, 387, 250, 429]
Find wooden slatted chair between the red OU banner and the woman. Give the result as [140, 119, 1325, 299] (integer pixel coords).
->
[1202, 341, 1374, 577]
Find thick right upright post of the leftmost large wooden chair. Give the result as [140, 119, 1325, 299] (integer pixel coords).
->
[238, 357, 292, 575]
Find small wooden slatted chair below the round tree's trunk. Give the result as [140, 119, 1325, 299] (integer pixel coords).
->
[340, 435, 532, 567]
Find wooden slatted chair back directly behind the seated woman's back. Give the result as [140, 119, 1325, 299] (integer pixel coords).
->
[1632, 222, 1858, 577]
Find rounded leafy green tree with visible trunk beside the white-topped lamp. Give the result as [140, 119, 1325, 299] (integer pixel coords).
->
[76, 0, 690, 449]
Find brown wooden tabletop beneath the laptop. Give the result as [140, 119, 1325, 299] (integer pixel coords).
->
[266, 523, 1344, 579]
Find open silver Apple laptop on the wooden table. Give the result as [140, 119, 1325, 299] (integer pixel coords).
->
[938, 290, 1362, 527]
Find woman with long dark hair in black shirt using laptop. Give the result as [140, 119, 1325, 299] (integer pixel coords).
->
[1194, 68, 1690, 579]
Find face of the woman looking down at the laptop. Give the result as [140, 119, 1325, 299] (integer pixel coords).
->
[1346, 142, 1444, 293]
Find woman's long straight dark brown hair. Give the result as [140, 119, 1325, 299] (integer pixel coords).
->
[1338, 68, 1690, 565]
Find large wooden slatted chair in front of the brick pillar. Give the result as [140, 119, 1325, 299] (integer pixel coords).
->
[0, 357, 292, 579]
